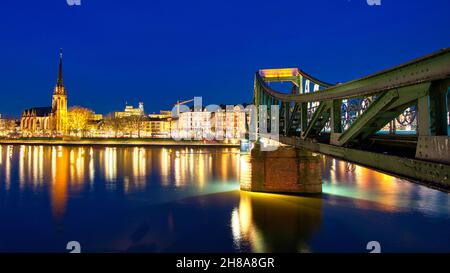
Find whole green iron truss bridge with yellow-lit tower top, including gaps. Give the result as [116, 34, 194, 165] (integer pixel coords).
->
[253, 48, 450, 190]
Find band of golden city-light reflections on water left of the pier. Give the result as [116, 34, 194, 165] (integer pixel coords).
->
[0, 145, 238, 218]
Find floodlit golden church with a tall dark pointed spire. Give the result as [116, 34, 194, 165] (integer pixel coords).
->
[20, 50, 67, 136]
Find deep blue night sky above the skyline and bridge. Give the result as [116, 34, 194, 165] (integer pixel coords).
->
[0, 0, 450, 116]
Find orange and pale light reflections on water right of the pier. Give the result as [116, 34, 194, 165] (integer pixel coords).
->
[322, 156, 450, 216]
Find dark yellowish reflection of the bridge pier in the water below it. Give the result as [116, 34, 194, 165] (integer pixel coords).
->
[231, 191, 323, 252]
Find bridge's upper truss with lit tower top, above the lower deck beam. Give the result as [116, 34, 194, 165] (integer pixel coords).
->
[254, 46, 450, 146]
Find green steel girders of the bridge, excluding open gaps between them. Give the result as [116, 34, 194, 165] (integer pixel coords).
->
[254, 48, 450, 186]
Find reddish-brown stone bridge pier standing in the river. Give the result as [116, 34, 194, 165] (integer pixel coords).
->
[240, 145, 322, 194]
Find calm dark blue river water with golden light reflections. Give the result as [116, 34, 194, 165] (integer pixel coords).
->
[0, 145, 450, 252]
